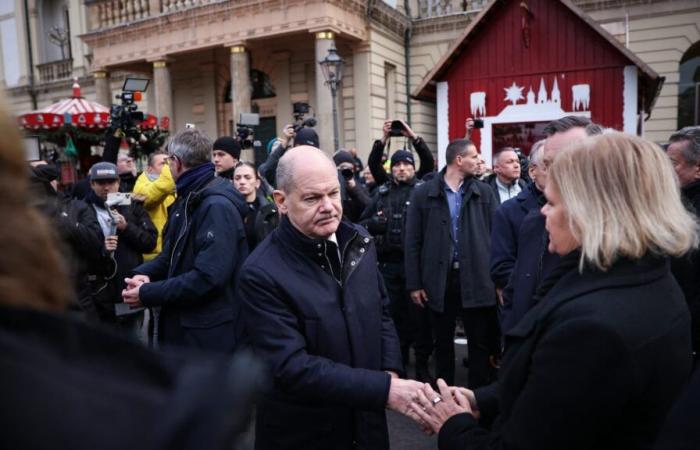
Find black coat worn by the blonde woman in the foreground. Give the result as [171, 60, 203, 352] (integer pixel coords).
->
[439, 255, 691, 450]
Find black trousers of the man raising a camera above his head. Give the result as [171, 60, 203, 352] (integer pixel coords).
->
[379, 262, 433, 364]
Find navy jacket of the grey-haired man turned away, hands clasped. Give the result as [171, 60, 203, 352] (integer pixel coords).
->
[134, 176, 248, 351]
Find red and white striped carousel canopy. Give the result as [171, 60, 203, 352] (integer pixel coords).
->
[18, 78, 109, 131]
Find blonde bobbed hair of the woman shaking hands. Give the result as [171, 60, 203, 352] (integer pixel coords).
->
[547, 133, 698, 270]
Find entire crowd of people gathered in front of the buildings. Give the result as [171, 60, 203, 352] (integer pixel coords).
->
[0, 83, 700, 450]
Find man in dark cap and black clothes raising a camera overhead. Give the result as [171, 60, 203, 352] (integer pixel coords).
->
[360, 120, 435, 382]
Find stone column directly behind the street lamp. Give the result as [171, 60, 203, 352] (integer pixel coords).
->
[311, 31, 342, 155]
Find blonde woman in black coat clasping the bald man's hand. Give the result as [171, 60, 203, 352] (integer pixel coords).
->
[412, 133, 698, 450]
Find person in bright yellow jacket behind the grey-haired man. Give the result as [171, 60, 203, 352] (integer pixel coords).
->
[134, 152, 175, 261]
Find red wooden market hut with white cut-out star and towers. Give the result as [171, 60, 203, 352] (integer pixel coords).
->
[413, 0, 664, 166]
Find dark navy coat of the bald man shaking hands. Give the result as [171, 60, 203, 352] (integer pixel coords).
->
[240, 217, 402, 450]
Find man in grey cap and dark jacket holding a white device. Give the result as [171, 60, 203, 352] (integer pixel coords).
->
[85, 162, 158, 330]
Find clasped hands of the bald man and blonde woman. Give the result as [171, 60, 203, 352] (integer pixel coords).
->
[387, 377, 479, 434]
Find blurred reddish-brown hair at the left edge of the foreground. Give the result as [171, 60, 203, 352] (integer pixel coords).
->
[0, 92, 72, 310]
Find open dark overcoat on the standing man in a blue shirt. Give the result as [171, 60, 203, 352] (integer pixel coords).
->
[404, 169, 498, 312]
